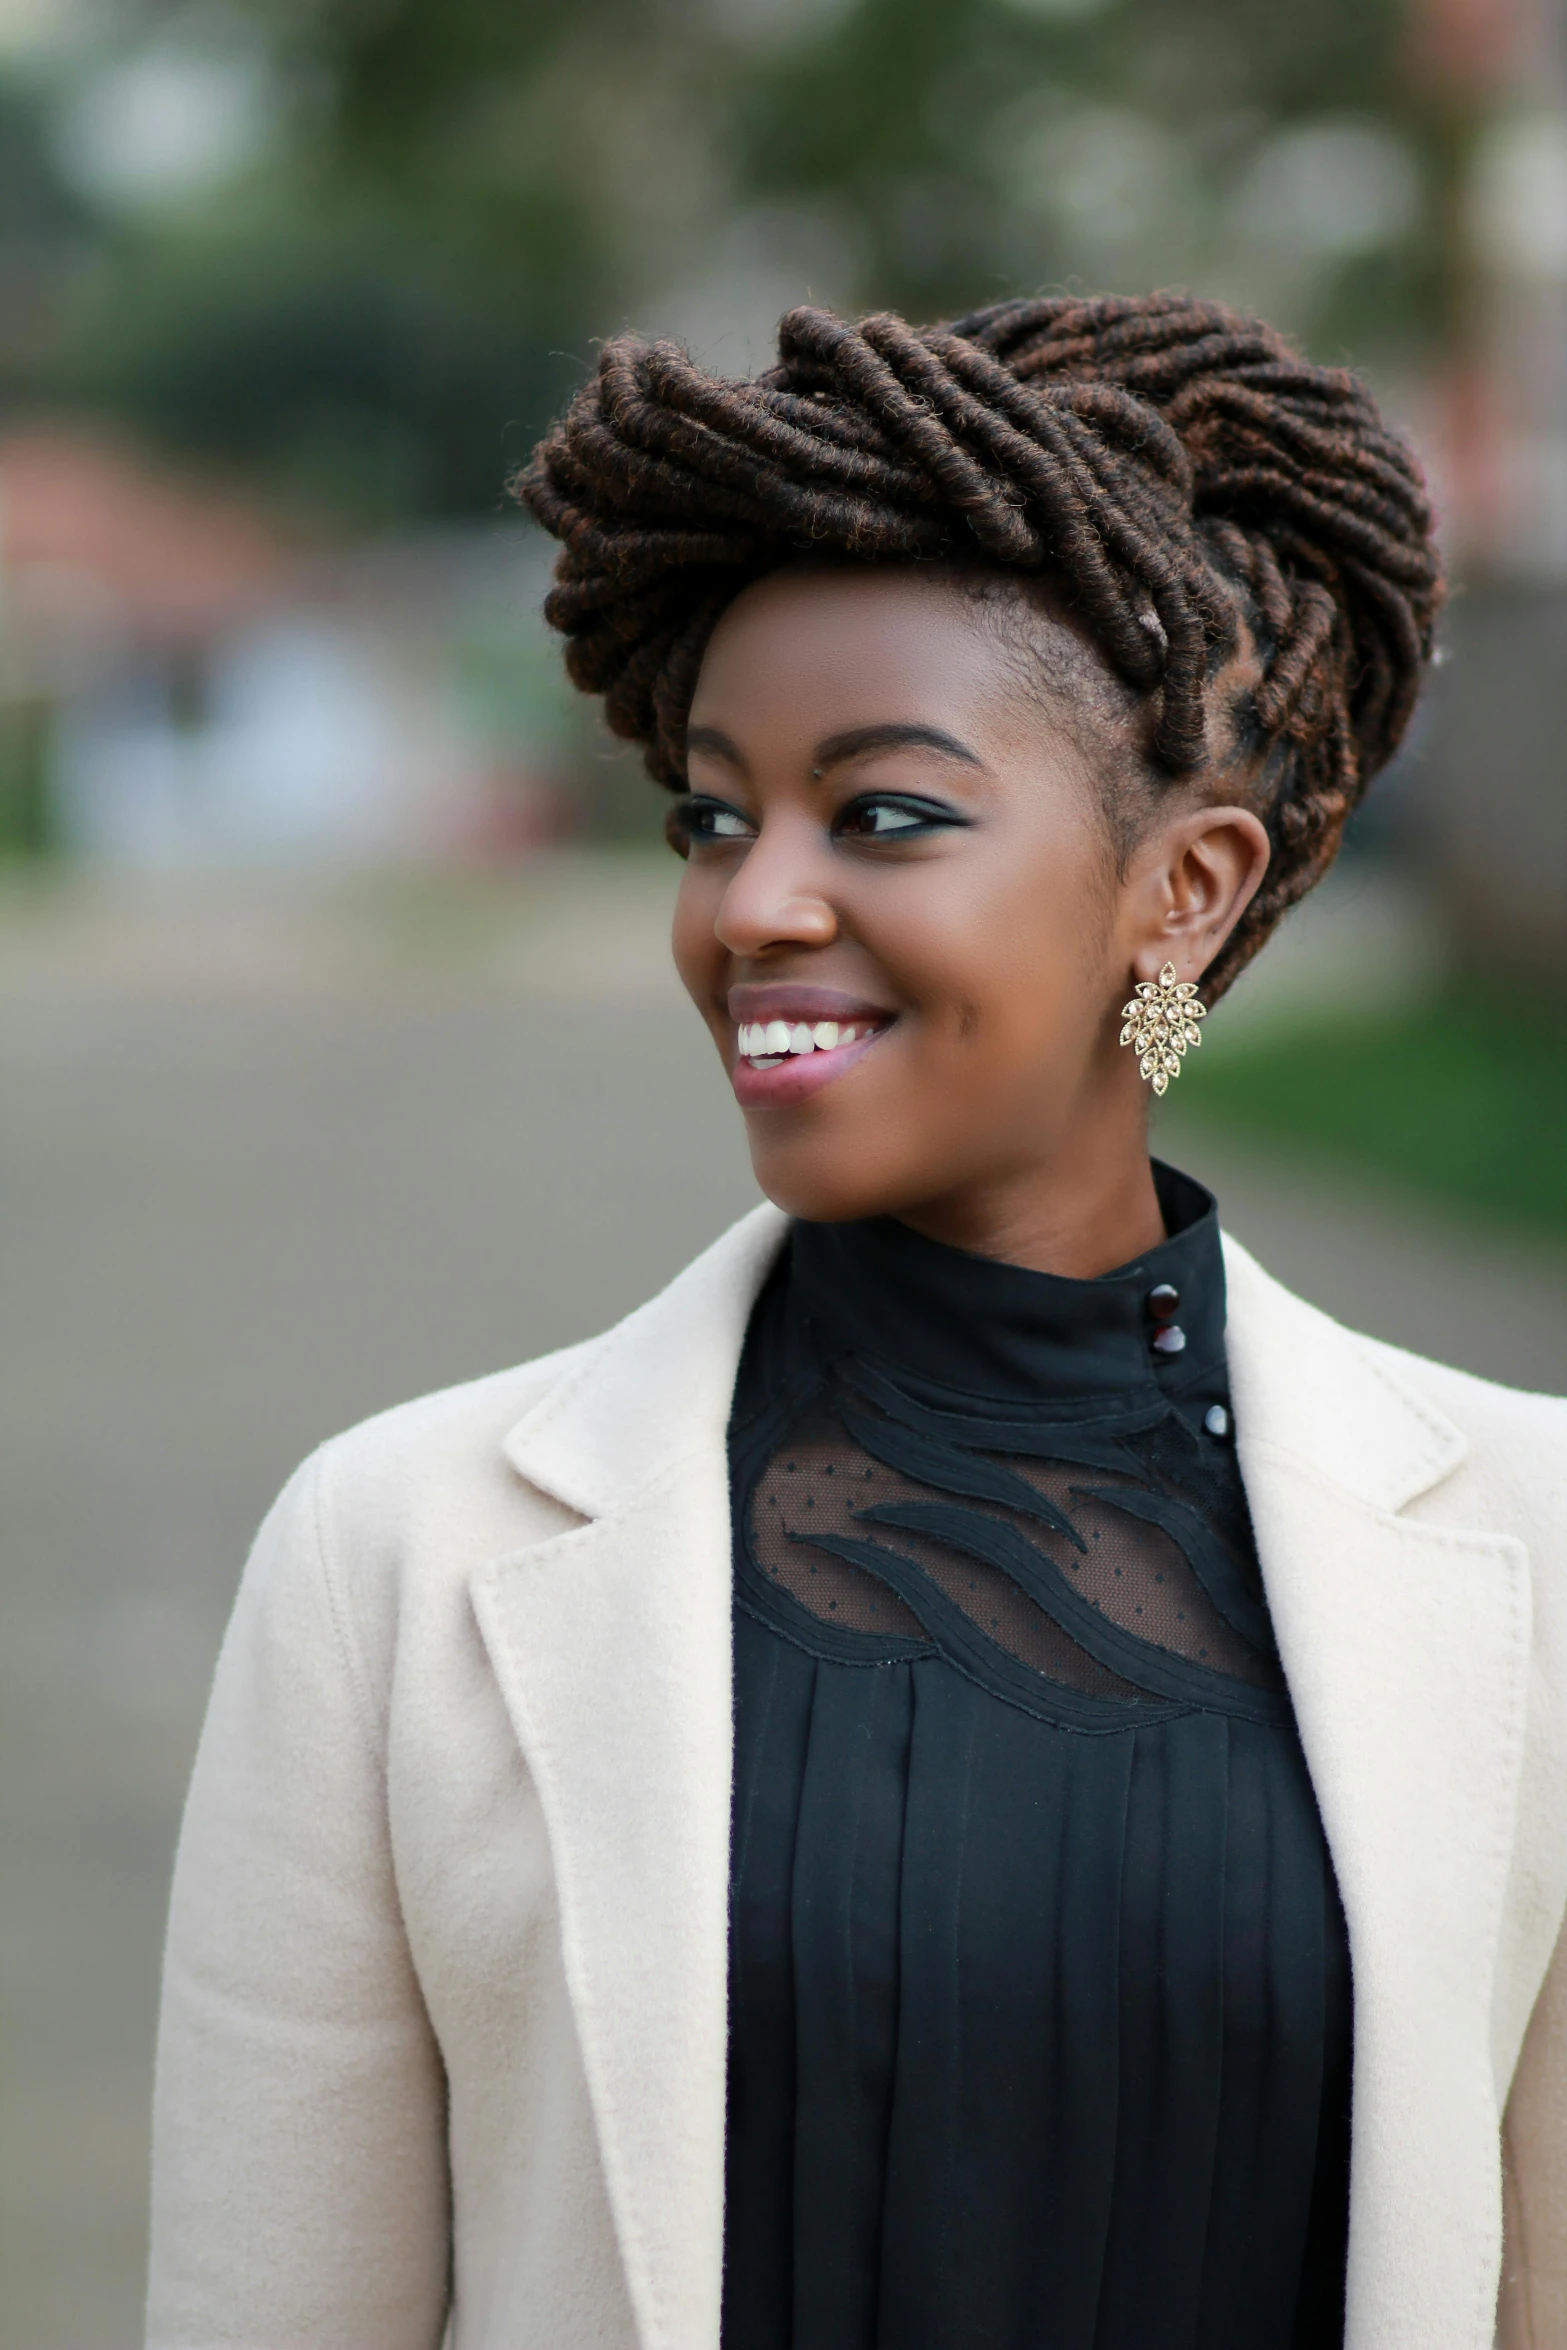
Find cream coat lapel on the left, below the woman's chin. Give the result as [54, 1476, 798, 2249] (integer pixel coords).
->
[472, 1208, 785, 2350]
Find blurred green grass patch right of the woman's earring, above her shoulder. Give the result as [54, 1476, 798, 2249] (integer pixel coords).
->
[1179, 982, 1567, 1238]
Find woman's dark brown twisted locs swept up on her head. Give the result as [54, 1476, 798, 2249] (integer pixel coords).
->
[517, 294, 1440, 992]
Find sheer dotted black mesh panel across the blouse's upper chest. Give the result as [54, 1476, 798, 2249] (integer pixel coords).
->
[749, 1396, 1278, 1697]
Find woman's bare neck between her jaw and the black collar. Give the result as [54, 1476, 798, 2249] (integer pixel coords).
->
[897, 1119, 1165, 1281]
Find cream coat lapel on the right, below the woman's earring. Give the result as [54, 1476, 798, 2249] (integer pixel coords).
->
[1226, 1246, 1529, 2350]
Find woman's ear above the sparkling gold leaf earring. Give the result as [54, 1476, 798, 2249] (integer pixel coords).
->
[1123, 808, 1271, 980]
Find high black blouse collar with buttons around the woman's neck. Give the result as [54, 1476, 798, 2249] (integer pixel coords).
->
[789, 1161, 1224, 1403]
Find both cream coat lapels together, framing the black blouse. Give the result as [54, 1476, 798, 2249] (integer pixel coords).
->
[483, 1208, 1529, 2350]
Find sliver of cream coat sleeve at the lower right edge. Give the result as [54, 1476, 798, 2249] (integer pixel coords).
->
[1497, 1927, 1567, 2350]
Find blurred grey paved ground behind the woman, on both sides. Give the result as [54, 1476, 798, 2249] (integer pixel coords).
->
[0, 874, 1567, 2350]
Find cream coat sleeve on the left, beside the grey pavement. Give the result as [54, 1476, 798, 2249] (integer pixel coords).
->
[148, 1457, 449, 2350]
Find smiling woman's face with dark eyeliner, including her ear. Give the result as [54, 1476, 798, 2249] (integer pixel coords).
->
[672, 566, 1266, 1246]
